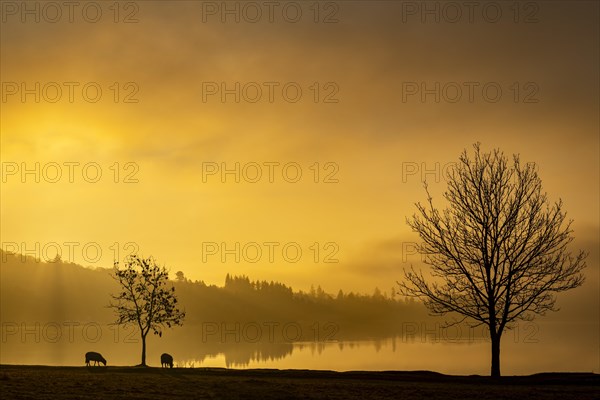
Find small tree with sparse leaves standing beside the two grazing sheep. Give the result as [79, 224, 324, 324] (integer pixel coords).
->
[109, 255, 185, 366]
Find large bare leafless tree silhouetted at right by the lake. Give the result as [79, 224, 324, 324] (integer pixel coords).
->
[399, 143, 587, 377]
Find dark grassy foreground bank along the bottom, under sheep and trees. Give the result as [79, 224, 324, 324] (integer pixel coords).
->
[0, 365, 600, 400]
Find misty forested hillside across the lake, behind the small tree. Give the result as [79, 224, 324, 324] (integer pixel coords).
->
[0, 250, 427, 342]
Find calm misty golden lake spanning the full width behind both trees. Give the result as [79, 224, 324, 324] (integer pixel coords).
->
[0, 323, 600, 375]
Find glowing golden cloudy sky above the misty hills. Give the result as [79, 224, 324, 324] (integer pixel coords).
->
[0, 1, 600, 298]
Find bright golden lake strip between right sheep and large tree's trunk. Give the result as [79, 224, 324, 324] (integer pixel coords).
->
[181, 337, 488, 374]
